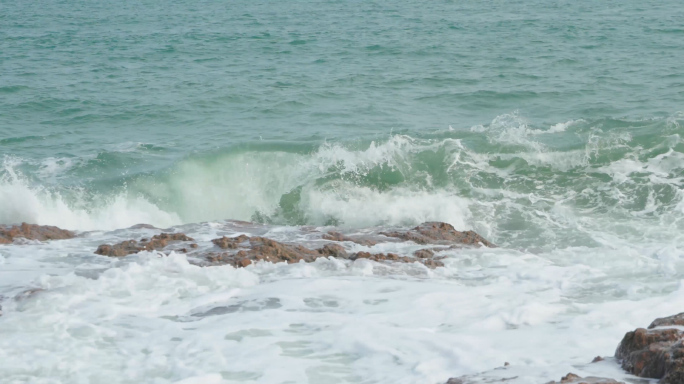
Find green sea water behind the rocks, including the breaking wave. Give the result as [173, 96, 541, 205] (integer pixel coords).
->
[0, 0, 684, 246]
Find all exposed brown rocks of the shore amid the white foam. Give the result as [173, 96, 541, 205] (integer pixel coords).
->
[0, 222, 684, 384]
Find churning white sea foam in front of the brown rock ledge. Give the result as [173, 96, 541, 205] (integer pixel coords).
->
[0, 227, 684, 384]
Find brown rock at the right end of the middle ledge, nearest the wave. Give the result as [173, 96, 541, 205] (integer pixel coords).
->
[380, 222, 495, 247]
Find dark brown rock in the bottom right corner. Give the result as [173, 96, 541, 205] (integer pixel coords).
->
[615, 313, 684, 384]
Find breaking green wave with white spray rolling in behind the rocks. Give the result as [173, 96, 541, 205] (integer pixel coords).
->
[0, 114, 684, 248]
